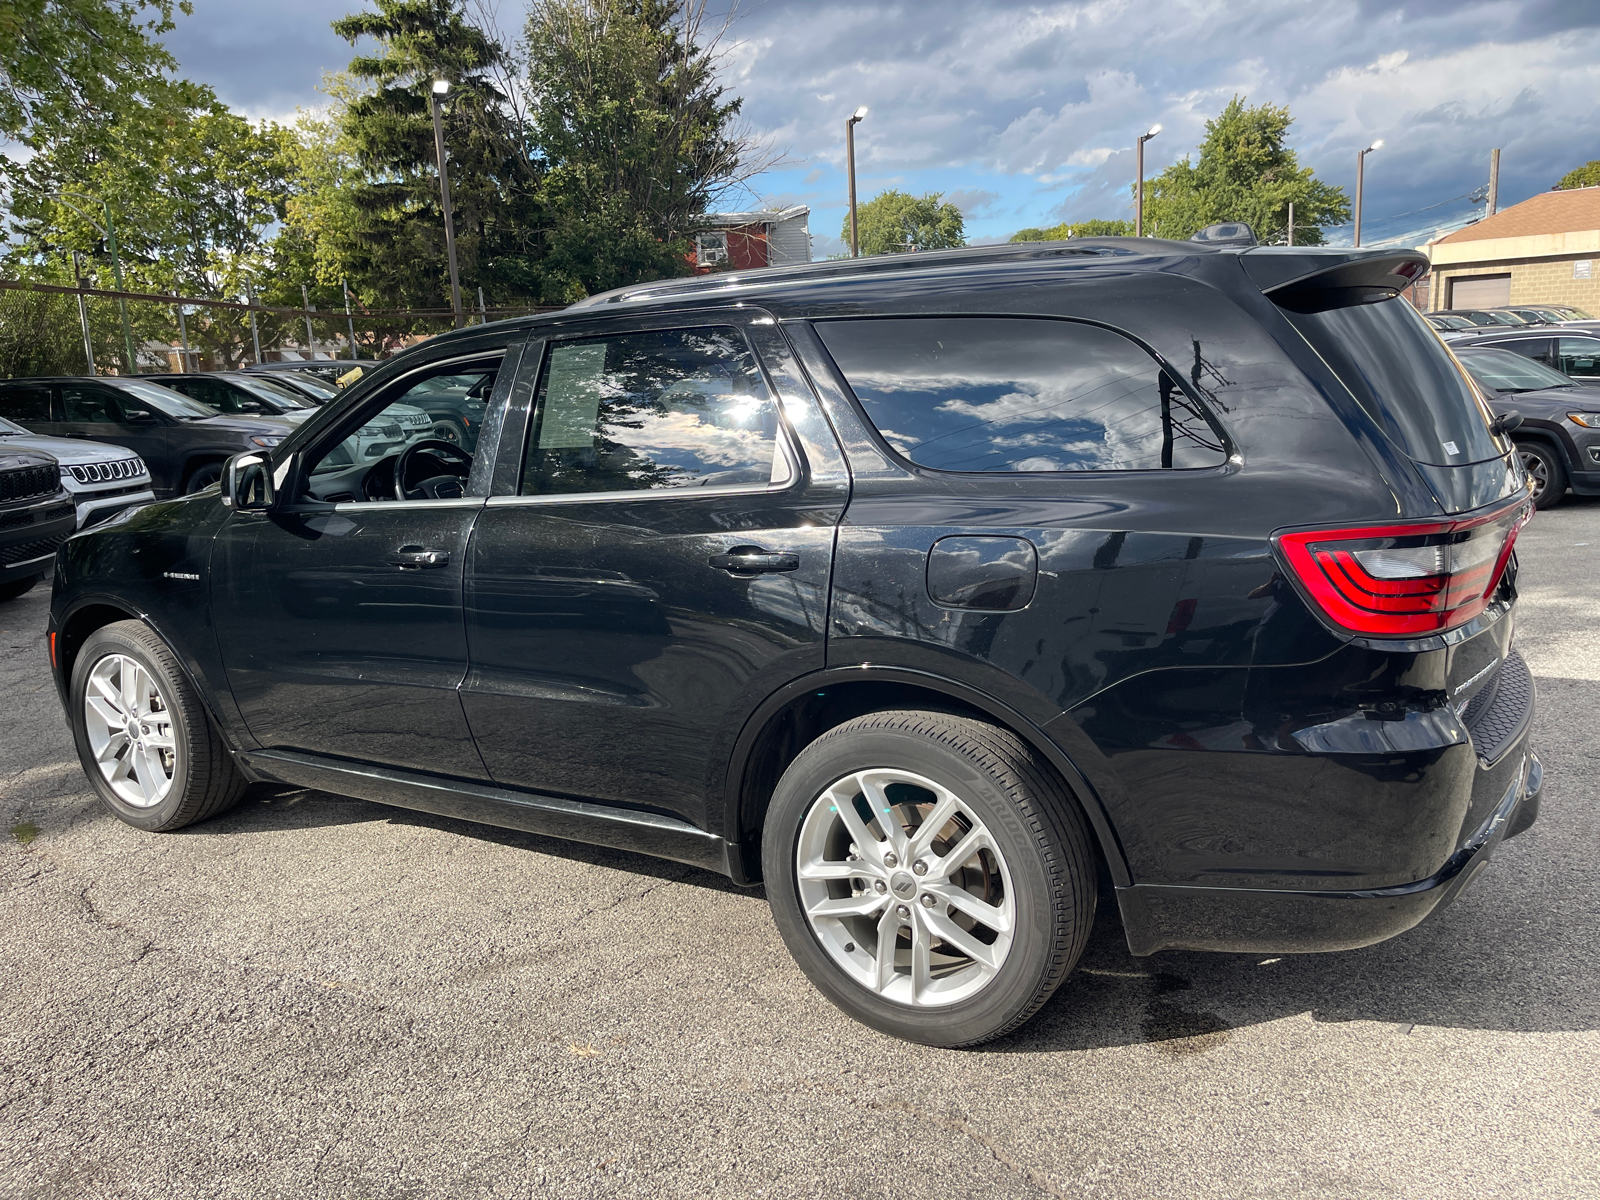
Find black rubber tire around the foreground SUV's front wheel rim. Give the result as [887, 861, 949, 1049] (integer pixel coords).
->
[67, 621, 250, 834]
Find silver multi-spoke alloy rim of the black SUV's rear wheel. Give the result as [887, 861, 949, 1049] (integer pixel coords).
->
[795, 768, 1016, 1008]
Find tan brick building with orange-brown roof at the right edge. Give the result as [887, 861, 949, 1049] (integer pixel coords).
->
[1427, 187, 1600, 314]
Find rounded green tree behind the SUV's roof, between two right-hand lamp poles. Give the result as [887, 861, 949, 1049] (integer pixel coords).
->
[1144, 96, 1350, 245]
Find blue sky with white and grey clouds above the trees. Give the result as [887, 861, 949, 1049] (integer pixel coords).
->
[159, 0, 1600, 256]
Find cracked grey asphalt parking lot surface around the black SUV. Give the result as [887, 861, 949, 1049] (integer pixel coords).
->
[0, 499, 1600, 1200]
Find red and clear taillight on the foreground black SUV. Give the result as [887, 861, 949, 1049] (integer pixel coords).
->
[1274, 499, 1533, 637]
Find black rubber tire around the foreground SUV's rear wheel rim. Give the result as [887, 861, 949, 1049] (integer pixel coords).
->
[762, 710, 1096, 1046]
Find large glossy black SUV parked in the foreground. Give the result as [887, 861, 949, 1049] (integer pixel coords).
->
[50, 238, 1541, 1045]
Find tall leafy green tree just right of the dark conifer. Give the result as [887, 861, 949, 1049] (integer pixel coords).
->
[525, 0, 748, 299]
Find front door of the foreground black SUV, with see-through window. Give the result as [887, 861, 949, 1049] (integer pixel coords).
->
[211, 331, 526, 779]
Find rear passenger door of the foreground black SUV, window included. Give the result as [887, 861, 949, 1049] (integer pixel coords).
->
[462, 309, 848, 827]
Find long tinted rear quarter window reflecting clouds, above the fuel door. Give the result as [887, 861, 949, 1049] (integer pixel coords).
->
[816, 317, 1227, 472]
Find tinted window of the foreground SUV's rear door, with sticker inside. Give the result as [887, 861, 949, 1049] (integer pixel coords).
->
[522, 328, 789, 496]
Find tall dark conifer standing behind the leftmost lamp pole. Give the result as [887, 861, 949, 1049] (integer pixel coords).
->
[328, 0, 544, 309]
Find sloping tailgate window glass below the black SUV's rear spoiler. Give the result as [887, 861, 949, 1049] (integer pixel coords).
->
[1283, 298, 1504, 467]
